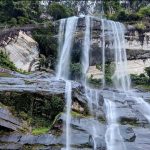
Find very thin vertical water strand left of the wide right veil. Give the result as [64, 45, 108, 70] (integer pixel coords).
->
[101, 19, 105, 88]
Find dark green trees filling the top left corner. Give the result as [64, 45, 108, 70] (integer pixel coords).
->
[0, 0, 41, 26]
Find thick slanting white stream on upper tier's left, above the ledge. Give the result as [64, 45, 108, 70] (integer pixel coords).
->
[57, 17, 78, 79]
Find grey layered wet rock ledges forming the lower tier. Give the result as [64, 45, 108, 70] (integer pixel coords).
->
[0, 72, 150, 150]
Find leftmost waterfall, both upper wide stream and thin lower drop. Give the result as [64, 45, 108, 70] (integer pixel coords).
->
[57, 17, 78, 150]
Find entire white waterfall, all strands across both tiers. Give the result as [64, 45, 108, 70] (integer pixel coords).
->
[57, 16, 145, 150]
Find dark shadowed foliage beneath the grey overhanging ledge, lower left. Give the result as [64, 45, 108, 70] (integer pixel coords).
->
[0, 92, 64, 122]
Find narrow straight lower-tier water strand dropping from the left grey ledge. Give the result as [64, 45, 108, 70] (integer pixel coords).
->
[65, 81, 72, 150]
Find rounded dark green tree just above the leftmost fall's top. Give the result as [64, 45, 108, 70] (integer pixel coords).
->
[48, 3, 73, 20]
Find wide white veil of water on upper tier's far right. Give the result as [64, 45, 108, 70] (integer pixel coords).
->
[109, 21, 130, 92]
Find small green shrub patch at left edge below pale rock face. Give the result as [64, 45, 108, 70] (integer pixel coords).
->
[0, 50, 17, 71]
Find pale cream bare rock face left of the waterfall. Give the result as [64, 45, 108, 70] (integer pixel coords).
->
[0, 31, 39, 71]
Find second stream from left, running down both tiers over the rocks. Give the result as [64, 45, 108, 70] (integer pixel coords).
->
[82, 16, 99, 150]
